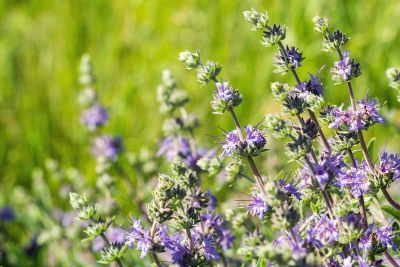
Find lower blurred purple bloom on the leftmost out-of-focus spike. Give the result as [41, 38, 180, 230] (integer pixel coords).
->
[92, 135, 123, 160]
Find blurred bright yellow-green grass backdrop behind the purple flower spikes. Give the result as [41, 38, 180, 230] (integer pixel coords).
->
[0, 0, 400, 192]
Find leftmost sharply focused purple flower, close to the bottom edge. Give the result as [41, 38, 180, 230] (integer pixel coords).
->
[125, 219, 153, 258]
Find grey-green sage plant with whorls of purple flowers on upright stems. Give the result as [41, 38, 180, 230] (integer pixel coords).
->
[61, 10, 400, 267]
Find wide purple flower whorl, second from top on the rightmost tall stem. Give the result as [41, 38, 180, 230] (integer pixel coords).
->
[329, 99, 384, 132]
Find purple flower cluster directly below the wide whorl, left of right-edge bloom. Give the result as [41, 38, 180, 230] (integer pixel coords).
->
[337, 162, 371, 197]
